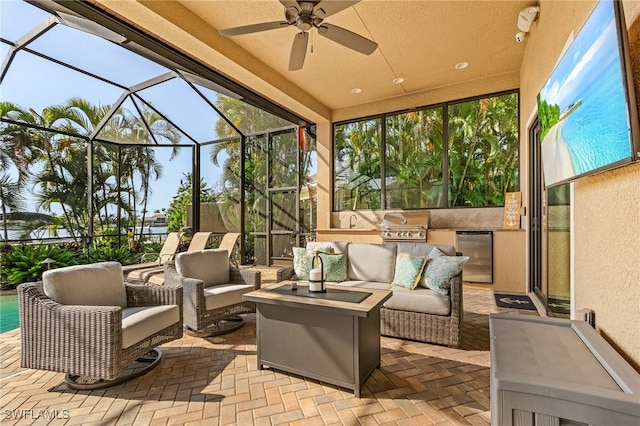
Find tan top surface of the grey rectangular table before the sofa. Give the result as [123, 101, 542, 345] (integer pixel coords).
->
[243, 281, 392, 316]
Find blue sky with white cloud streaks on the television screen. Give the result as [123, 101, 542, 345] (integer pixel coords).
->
[540, 0, 620, 111]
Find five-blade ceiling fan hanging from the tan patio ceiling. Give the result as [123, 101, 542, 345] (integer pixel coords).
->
[220, 0, 378, 71]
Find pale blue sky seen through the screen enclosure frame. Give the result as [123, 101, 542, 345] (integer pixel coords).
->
[0, 0, 228, 212]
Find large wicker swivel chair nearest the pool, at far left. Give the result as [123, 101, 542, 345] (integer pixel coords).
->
[18, 262, 183, 389]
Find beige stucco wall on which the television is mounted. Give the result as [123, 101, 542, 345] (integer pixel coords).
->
[520, 1, 640, 371]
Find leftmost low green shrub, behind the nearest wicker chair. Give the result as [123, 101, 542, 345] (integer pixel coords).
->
[0, 244, 82, 287]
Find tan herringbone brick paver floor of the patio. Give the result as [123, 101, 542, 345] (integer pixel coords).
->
[0, 287, 535, 426]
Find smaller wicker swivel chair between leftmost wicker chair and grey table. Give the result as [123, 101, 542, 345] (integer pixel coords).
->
[164, 249, 261, 337]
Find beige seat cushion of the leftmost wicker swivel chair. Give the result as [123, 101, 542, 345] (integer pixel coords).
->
[122, 305, 180, 349]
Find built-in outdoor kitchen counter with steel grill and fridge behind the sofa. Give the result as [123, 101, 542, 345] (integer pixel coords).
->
[316, 207, 527, 293]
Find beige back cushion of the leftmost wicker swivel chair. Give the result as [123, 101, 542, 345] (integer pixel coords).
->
[42, 262, 127, 308]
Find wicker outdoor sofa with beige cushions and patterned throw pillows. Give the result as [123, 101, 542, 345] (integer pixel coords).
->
[279, 241, 468, 347]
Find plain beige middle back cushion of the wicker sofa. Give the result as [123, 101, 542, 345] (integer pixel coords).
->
[347, 243, 396, 283]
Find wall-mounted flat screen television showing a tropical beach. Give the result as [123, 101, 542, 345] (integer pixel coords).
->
[538, 0, 640, 187]
